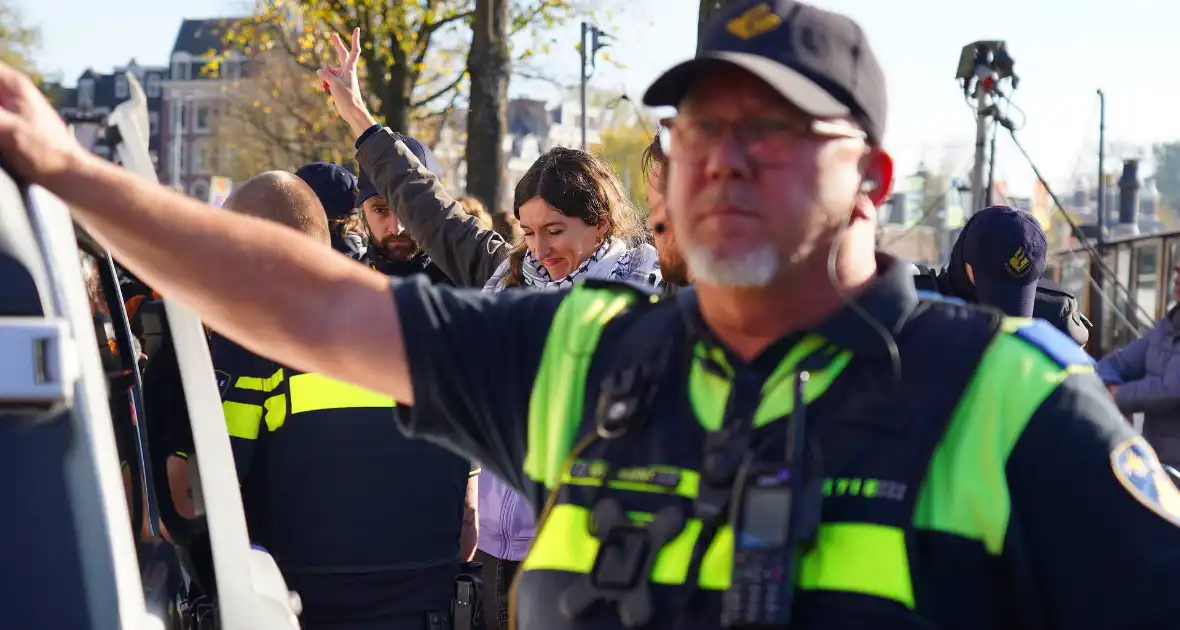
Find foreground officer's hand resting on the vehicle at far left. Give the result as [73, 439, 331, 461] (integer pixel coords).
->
[0, 63, 87, 189]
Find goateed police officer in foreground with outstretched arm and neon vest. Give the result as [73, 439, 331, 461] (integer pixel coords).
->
[0, 0, 1180, 630]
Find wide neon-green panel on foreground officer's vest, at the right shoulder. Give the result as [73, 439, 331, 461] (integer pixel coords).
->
[913, 317, 1093, 556]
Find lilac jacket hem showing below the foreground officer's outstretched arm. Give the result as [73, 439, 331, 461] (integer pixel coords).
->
[479, 470, 536, 562]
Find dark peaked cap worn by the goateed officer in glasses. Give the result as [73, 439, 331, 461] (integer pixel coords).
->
[643, 0, 886, 144]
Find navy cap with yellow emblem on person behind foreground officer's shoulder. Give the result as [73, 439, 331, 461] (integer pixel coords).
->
[961, 205, 1049, 317]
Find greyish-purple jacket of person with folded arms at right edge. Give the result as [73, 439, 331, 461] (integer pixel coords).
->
[1097, 308, 1180, 466]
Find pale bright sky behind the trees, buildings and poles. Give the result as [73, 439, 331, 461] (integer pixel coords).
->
[17, 0, 1180, 193]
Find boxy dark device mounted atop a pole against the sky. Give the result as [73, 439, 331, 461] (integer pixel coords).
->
[955, 40, 1020, 217]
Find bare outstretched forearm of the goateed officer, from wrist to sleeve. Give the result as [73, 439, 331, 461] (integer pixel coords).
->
[47, 156, 411, 402]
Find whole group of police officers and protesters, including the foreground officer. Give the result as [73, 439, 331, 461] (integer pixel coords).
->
[0, 0, 1180, 630]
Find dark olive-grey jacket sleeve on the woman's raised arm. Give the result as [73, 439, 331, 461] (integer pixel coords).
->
[356, 129, 512, 288]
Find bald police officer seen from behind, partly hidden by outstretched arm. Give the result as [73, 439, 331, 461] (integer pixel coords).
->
[210, 172, 478, 630]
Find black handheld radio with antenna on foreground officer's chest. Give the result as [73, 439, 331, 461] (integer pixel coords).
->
[721, 372, 822, 630]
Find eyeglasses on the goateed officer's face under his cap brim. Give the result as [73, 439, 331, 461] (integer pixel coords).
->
[660, 116, 868, 165]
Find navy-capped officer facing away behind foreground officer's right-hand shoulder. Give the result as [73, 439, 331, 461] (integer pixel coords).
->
[915, 205, 1092, 346]
